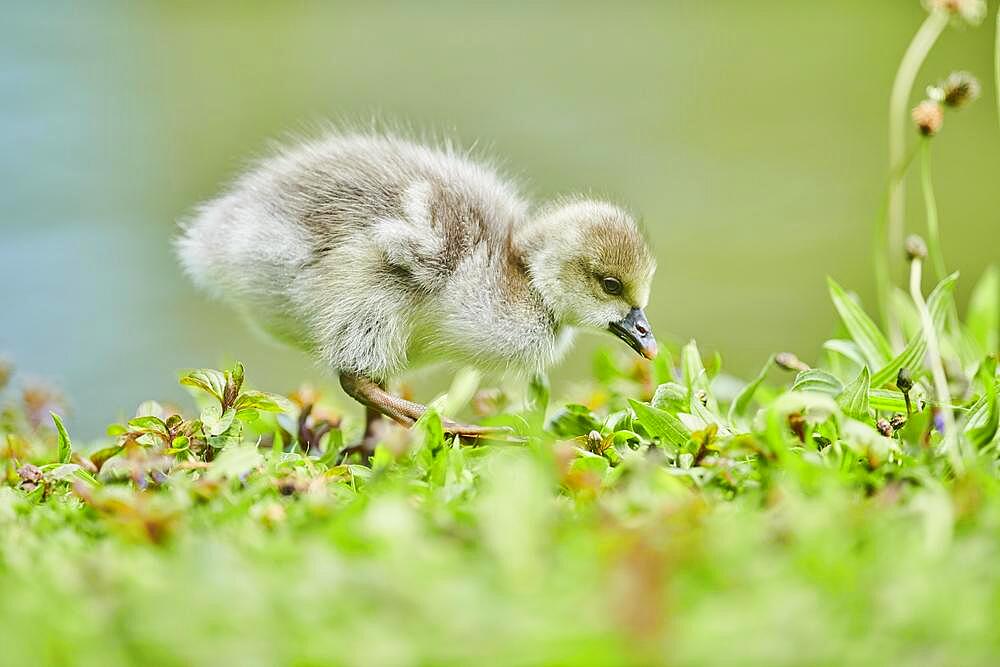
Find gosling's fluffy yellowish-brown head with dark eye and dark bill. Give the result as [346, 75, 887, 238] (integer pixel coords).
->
[527, 199, 656, 359]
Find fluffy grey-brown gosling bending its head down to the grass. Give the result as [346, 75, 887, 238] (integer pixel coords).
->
[177, 133, 656, 439]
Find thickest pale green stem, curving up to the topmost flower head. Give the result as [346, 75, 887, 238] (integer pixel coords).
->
[879, 9, 949, 302]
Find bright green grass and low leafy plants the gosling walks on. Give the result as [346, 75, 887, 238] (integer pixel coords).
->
[0, 1, 1000, 667]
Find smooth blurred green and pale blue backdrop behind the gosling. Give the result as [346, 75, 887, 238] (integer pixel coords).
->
[0, 0, 1000, 435]
